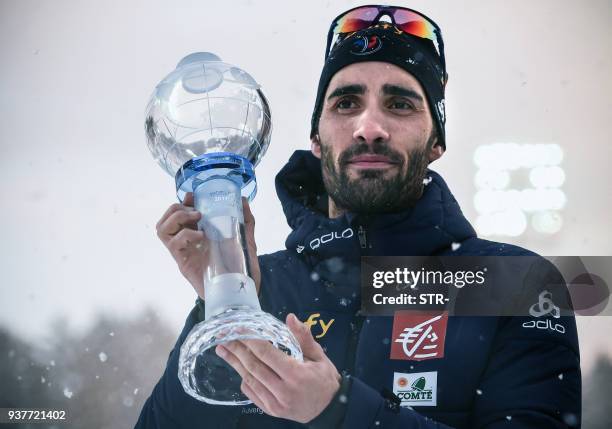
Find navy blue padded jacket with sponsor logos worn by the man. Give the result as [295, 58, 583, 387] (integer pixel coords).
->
[136, 151, 581, 429]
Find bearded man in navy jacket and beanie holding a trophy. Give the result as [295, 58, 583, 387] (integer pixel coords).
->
[136, 6, 581, 429]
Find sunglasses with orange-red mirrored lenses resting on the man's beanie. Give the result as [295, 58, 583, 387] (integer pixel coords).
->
[325, 5, 446, 69]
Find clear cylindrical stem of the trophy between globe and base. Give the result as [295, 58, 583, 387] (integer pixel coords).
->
[193, 175, 260, 320]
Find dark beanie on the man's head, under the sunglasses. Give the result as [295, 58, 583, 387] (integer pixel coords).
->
[310, 24, 447, 150]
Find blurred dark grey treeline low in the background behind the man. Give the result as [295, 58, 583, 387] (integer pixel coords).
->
[0, 309, 612, 429]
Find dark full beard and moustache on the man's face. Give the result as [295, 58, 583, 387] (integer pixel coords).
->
[321, 133, 435, 214]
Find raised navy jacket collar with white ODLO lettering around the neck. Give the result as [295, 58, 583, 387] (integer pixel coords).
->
[276, 150, 476, 263]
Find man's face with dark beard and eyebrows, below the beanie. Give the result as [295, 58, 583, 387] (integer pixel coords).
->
[312, 62, 443, 213]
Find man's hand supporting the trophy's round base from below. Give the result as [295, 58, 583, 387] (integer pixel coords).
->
[216, 314, 341, 423]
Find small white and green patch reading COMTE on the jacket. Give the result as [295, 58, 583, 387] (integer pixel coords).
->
[393, 371, 438, 407]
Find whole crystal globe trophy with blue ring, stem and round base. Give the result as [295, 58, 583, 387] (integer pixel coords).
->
[145, 52, 303, 405]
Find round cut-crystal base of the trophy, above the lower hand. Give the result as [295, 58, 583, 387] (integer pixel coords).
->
[178, 308, 303, 405]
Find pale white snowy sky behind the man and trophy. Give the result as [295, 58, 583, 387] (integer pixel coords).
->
[0, 0, 612, 374]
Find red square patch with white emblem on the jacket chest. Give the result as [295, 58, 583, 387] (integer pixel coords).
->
[391, 310, 448, 360]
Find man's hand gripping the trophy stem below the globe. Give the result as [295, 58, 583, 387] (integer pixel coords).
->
[156, 192, 261, 299]
